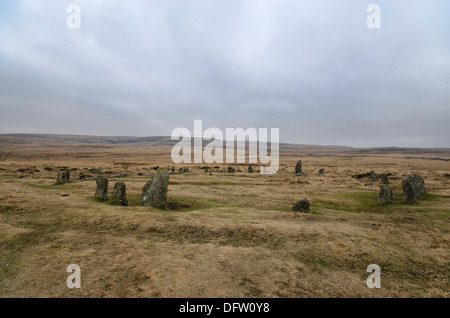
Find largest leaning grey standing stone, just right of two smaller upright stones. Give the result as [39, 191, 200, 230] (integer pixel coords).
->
[141, 168, 169, 209]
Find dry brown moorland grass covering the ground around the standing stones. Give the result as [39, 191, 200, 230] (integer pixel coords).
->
[0, 137, 450, 297]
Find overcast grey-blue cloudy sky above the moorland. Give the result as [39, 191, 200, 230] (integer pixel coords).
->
[0, 0, 450, 147]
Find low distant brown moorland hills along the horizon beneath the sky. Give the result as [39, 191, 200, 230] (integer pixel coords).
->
[0, 134, 450, 160]
